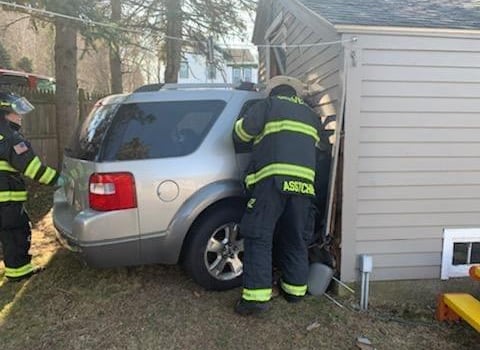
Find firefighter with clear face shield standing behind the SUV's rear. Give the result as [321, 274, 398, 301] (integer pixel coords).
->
[0, 92, 63, 281]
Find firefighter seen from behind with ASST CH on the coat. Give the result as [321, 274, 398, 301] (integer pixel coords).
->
[233, 76, 320, 315]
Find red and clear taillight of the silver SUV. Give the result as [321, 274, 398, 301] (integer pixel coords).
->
[88, 173, 137, 211]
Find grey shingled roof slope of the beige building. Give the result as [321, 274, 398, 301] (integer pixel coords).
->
[298, 0, 480, 29]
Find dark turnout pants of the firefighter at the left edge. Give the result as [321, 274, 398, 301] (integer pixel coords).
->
[0, 203, 33, 278]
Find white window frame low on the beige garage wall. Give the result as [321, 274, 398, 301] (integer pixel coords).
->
[440, 228, 480, 280]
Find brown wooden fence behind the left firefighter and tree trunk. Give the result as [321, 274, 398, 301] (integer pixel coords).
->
[7, 88, 105, 167]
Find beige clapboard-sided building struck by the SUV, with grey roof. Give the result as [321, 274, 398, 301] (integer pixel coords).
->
[253, 0, 480, 281]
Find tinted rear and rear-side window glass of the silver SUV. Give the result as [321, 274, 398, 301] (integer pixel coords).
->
[66, 100, 226, 161]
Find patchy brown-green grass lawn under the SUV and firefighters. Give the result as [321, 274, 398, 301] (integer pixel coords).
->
[0, 186, 480, 350]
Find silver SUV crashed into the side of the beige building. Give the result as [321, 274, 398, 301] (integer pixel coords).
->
[53, 85, 264, 290]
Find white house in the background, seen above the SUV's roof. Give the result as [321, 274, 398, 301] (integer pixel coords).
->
[178, 49, 258, 84]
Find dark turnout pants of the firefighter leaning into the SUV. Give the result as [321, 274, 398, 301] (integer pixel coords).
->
[240, 179, 313, 302]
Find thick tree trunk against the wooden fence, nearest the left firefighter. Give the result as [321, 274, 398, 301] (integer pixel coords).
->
[55, 18, 78, 170]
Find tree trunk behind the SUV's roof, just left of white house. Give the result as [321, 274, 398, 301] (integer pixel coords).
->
[165, 0, 183, 83]
